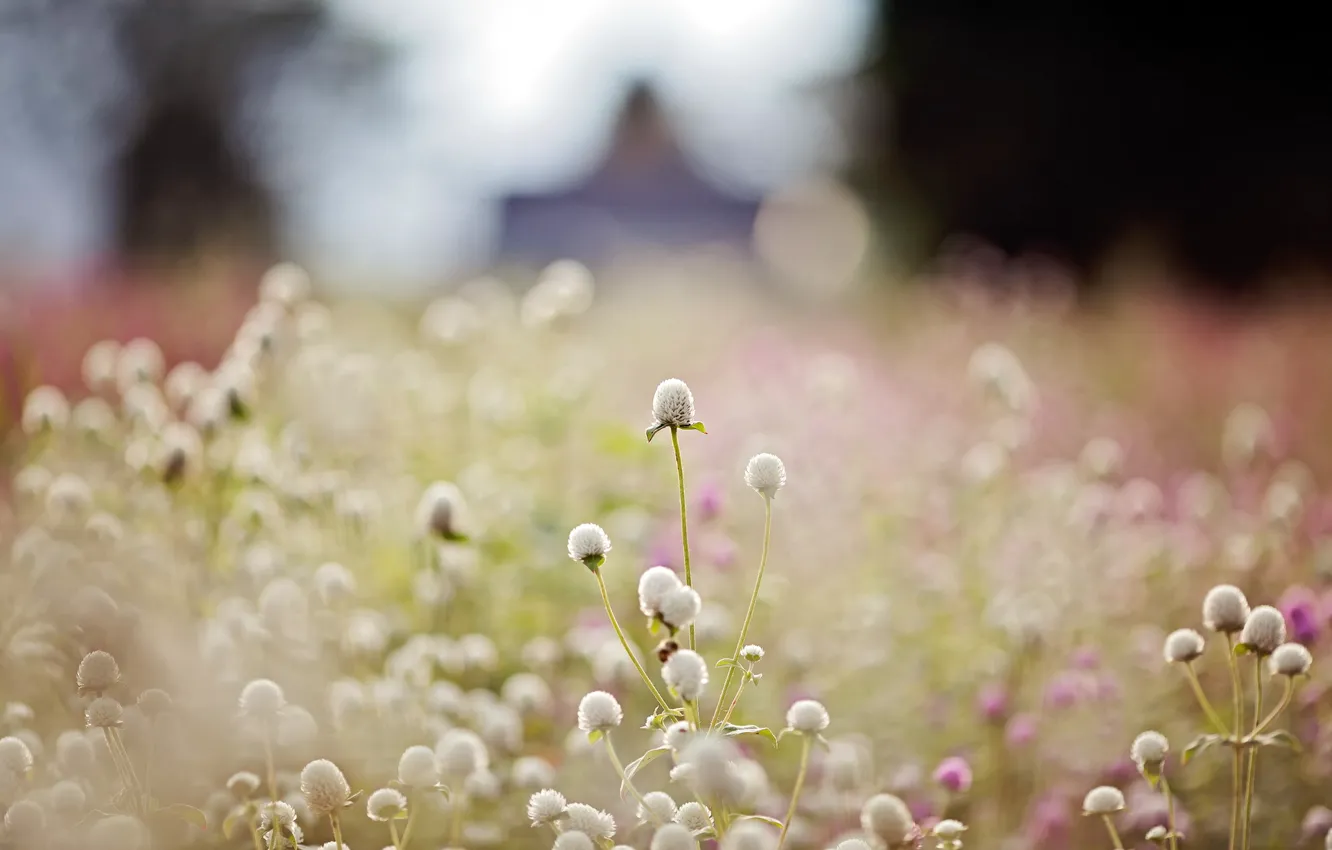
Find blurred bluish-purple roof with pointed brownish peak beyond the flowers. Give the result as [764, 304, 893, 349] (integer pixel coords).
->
[500, 85, 758, 264]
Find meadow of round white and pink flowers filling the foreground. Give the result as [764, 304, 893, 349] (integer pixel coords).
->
[0, 262, 1332, 850]
